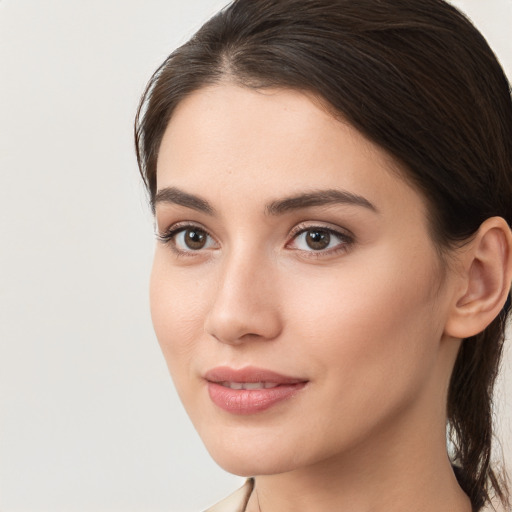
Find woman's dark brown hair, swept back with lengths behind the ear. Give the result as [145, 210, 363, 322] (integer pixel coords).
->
[135, 0, 512, 511]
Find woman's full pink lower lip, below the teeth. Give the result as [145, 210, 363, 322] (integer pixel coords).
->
[208, 382, 306, 414]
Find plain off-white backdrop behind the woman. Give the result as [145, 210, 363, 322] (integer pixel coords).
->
[0, 0, 512, 512]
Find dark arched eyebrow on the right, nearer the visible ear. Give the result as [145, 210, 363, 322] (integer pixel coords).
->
[265, 189, 379, 215]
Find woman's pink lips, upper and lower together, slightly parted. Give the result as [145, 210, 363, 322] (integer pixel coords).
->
[204, 366, 308, 415]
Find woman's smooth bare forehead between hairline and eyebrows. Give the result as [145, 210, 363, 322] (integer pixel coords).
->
[157, 84, 424, 220]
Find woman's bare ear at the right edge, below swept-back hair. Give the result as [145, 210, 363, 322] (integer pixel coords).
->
[445, 217, 512, 339]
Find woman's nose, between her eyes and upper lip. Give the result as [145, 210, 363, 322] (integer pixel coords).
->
[205, 248, 282, 345]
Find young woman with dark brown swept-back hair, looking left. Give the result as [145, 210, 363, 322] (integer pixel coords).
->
[136, 0, 512, 512]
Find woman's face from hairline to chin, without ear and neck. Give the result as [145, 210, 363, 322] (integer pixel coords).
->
[151, 84, 456, 475]
